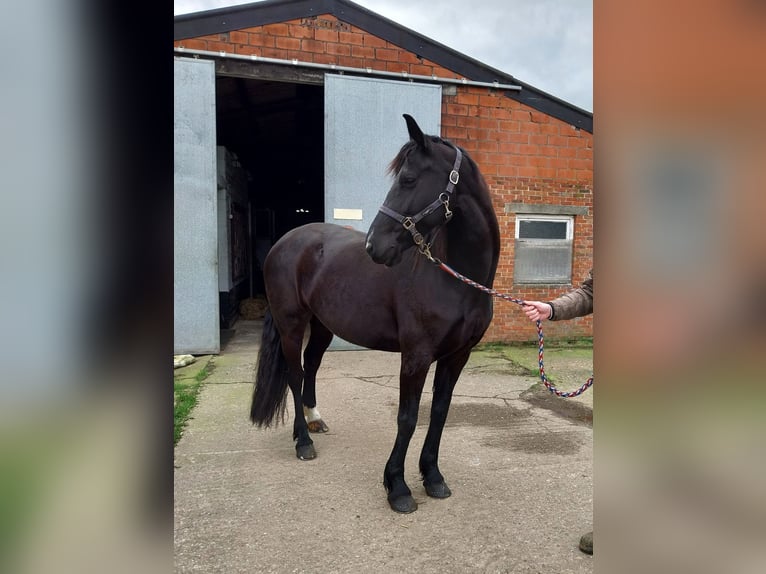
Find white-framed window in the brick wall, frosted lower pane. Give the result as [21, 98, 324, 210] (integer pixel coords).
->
[513, 214, 574, 284]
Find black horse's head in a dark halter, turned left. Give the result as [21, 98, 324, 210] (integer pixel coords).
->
[366, 114, 462, 267]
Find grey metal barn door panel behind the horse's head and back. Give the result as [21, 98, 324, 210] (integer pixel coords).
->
[324, 74, 441, 349]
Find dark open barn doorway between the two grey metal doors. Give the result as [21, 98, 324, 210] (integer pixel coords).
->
[216, 76, 325, 329]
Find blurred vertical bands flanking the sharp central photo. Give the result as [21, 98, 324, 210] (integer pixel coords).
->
[0, 0, 766, 574]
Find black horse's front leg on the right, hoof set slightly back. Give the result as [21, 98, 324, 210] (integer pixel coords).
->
[419, 349, 471, 498]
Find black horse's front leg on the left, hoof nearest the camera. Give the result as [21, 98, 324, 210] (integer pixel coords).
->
[383, 358, 428, 513]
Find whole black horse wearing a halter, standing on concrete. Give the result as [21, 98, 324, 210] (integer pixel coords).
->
[250, 115, 500, 512]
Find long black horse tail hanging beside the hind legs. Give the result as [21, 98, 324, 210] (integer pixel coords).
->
[250, 311, 288, 427]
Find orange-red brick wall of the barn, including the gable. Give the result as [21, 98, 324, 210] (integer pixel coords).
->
[174, 15, 593, 341]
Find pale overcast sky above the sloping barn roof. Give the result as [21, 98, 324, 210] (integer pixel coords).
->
[174, 0, 593, 111]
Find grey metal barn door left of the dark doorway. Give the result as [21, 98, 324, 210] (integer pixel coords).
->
[173, 58, 220, 354]
